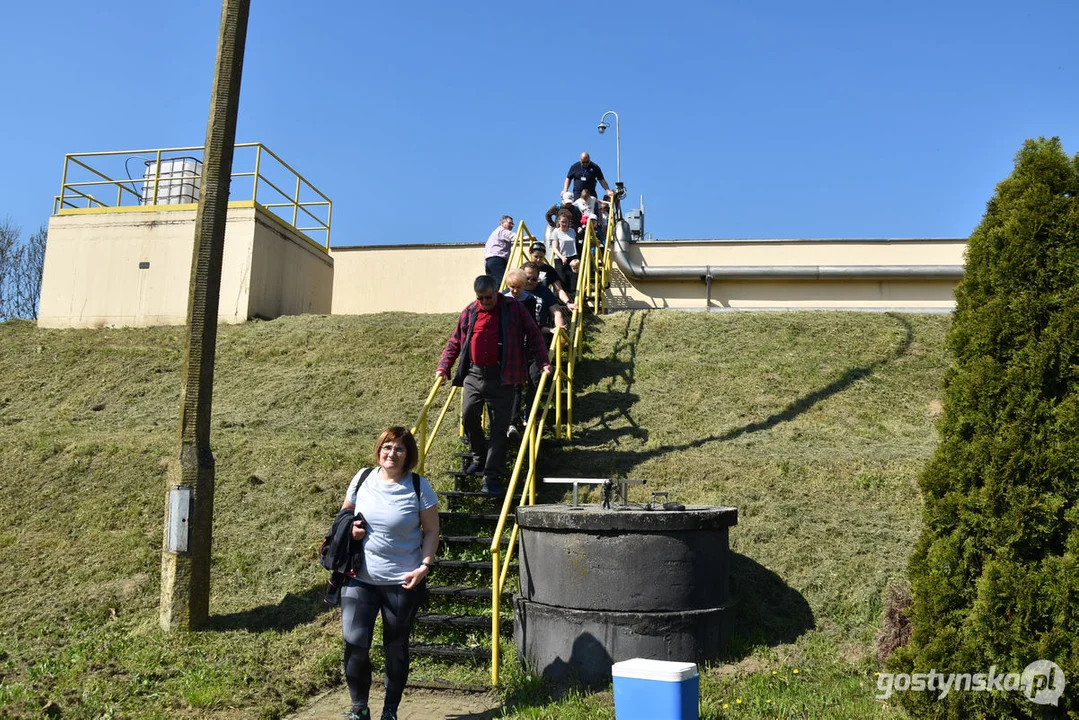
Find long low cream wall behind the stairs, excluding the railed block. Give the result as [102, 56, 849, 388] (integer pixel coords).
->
[331, 239, 966, 314]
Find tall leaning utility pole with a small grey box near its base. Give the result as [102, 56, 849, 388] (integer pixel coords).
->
[160, 0, 250, 630]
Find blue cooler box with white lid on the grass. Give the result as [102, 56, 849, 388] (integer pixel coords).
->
[611, 657, 700, 720]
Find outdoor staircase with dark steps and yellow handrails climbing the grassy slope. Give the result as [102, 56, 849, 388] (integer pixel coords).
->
[409, 208, 622, 691]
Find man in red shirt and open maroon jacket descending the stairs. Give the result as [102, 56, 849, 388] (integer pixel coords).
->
[435, 275, 551, 495]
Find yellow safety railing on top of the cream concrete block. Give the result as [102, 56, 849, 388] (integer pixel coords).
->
[53, 142, 333, 250]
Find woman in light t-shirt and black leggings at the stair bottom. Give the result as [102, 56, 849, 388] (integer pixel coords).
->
[341, 426, 438, 720]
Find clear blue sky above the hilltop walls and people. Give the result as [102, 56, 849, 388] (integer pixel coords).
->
[0, 0, 1079, 245]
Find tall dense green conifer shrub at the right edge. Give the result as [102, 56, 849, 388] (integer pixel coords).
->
[888, 138, 1079, 718]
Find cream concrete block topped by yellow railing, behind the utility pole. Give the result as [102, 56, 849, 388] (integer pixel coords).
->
[38, 205, 332, 327]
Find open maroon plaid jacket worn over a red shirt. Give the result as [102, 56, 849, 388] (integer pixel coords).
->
[438, 294, 550, 386]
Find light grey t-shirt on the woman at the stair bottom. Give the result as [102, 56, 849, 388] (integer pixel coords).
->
[345, 467, 438, 585]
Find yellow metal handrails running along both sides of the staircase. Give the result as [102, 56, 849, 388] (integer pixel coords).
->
[412, 199, 622, 684]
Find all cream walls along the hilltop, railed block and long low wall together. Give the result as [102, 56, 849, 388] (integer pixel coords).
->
[39, 221, 966, 327]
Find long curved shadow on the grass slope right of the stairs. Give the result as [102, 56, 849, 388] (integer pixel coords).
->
[573, 313, 914, 477]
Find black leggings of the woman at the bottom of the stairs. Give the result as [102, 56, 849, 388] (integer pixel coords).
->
[341, 580, 420, 710]
